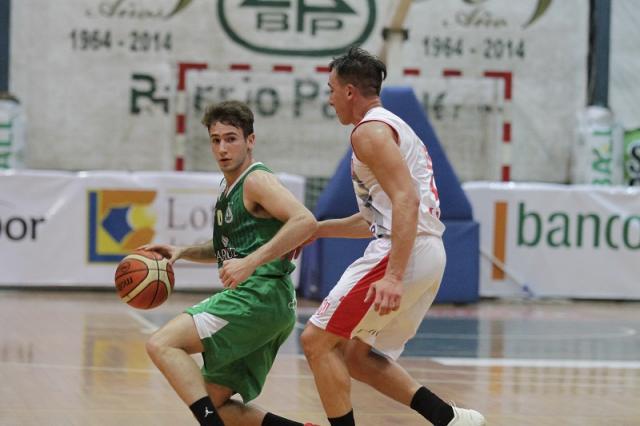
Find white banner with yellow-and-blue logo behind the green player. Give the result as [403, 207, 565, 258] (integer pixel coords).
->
[0, 171, 304, 289]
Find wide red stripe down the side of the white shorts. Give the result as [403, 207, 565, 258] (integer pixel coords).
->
[327, 255, 389, 339]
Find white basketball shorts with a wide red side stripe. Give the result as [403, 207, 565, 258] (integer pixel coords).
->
[309, 235, 446, 359]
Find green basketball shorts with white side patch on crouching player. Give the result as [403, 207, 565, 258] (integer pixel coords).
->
[185, 276, 296, 403]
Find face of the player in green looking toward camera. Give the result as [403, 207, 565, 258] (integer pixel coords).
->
[209, 121, 255, 174]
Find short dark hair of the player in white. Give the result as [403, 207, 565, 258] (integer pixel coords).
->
[329, 46, 387, 96]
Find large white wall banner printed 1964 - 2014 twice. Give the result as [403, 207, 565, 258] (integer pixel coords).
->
[10, 0, 589, 182]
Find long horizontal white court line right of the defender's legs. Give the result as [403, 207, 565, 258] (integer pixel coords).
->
[431, 358, 640, 370]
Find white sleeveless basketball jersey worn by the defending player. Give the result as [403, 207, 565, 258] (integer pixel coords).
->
[351, 107, 445, 238]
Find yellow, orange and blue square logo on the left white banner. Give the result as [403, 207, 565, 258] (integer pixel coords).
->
[88, 190, 156, 262]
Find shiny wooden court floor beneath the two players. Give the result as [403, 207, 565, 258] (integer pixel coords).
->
[0, 290, 640, 426]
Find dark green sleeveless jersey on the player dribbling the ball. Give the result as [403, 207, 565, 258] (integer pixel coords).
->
[213, 163, 295, 277]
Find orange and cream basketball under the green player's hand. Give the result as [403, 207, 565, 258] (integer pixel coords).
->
[115, 250, 174, 309]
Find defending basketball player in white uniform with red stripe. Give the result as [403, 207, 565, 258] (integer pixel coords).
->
[301, 47, 486, 426]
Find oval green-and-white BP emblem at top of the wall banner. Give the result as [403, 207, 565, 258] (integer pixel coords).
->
[218, 0, 376, 56]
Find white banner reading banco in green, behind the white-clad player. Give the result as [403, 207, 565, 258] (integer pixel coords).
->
[464, 182, 640, 300]
